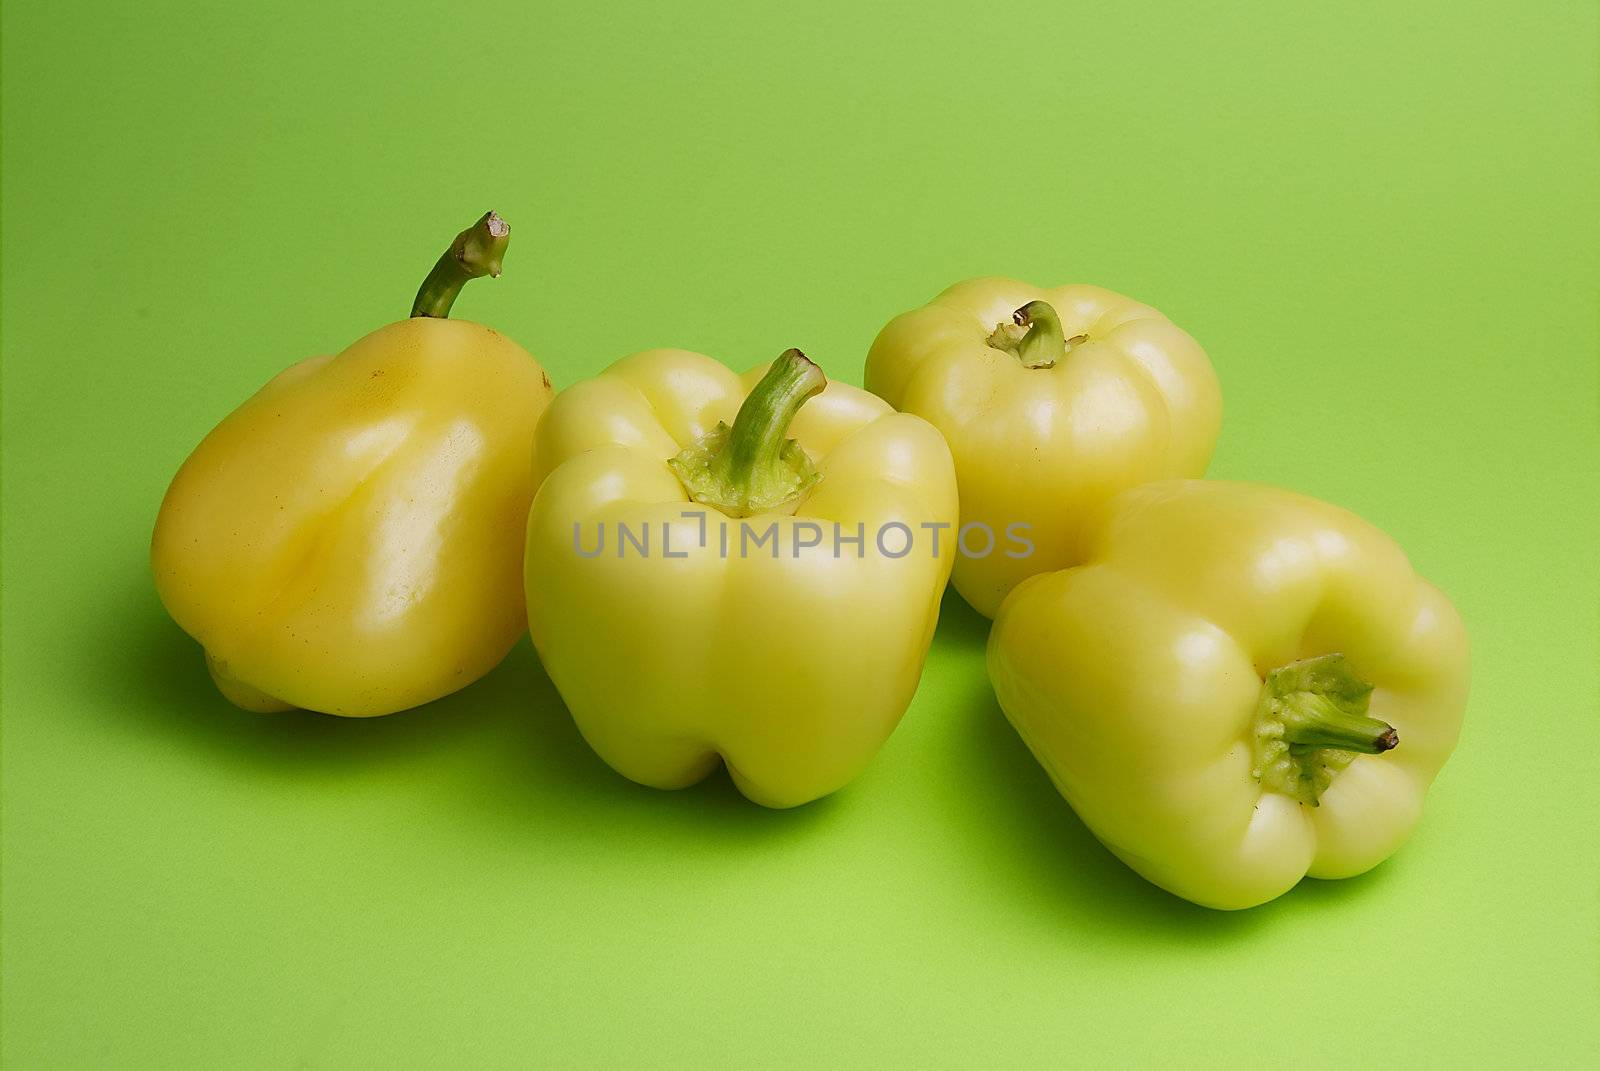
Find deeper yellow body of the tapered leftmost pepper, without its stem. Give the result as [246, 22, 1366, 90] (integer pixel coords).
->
[150, 319, 550, 717]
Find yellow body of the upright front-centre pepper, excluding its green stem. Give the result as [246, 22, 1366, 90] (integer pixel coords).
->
[525, 349, 957, 807]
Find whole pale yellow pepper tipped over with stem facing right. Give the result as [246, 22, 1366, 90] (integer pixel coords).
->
[989, 480, 1467, 908]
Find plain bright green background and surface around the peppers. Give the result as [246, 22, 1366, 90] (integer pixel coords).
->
[0, 0, 1600, 1068]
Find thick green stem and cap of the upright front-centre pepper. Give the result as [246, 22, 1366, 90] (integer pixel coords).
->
[667, 349, 827, 517]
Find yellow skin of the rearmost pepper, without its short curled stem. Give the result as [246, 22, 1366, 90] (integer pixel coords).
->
[866, 279, 1222, 618]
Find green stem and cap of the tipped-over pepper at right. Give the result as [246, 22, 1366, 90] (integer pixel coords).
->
[1253, 655, 1400, 807]
